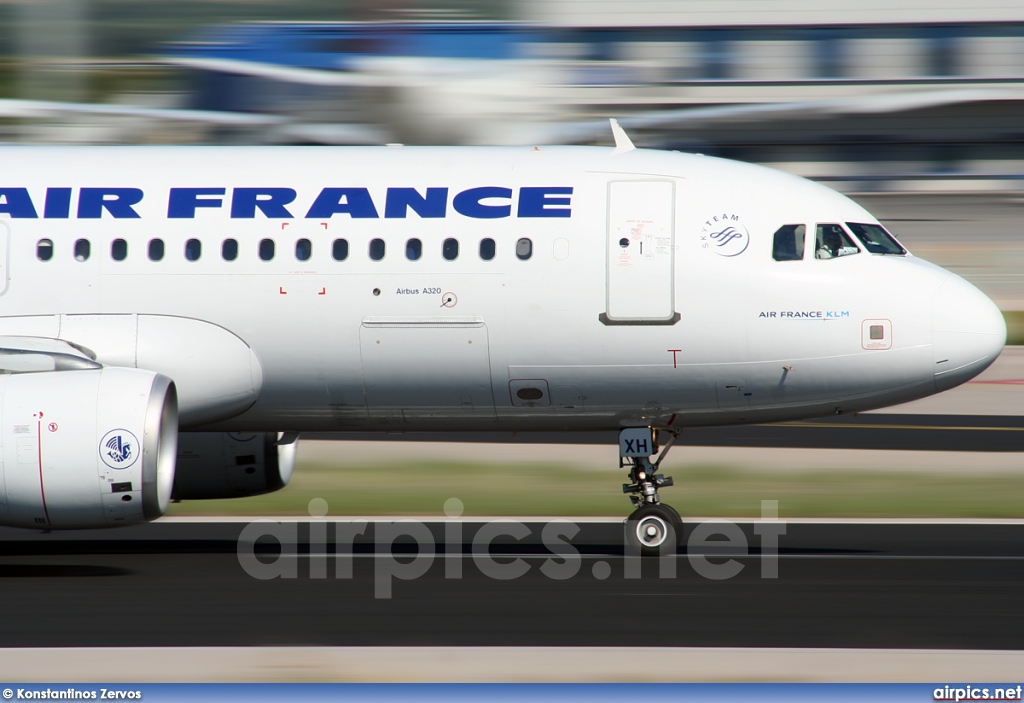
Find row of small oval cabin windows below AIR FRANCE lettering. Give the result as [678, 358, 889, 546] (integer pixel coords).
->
[36, 237, 534, 261]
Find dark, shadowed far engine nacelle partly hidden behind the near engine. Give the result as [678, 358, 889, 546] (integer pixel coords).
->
[172, 432, 298, 500]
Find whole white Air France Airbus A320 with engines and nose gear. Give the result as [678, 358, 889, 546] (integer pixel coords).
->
[0, 126, 1006, 552]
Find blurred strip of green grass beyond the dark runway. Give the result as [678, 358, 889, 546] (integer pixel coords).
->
[168, 462, 1024, 518]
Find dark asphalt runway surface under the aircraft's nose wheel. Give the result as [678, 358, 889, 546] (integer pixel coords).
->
[0, 521, 1024, 650]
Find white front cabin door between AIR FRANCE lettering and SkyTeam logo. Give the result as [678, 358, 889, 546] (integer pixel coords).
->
[601, 180, 679, 324]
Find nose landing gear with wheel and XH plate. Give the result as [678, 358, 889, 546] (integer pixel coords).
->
[618, 428, 683, 557]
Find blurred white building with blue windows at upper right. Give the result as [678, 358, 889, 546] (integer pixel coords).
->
[522, 0, 1024, 187]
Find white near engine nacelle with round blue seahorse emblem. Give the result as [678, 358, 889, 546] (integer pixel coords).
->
[0, 366, 178, 530]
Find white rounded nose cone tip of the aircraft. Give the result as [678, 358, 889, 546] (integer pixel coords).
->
[932, 275, 1007, 391]
